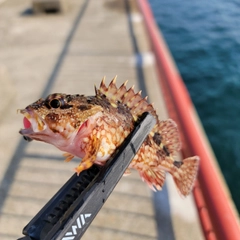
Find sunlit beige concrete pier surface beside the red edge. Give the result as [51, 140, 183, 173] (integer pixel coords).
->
[0, 0, 203, 240]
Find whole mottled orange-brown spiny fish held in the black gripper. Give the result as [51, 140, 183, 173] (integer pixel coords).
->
[19, 77, 200, 196]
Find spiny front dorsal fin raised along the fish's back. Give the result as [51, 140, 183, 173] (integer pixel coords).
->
[95, 76, 157, 119]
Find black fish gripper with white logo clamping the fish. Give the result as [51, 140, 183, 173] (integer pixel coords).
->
[19, 113, 156, 240]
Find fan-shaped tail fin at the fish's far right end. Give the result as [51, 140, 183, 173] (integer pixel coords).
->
[170, 156, 199, 196]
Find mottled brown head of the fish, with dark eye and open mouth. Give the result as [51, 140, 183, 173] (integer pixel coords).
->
[19, 93, 102, 148]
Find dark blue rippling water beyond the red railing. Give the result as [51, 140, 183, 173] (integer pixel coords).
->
[149, 0, 240, 212]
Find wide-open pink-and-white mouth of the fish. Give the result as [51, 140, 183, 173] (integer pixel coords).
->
[19, 109, 47, 137]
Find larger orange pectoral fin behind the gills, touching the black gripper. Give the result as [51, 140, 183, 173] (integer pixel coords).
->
[75, 136, 101, 175]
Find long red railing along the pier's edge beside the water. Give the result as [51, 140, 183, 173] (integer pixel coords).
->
[138, 0, 240, 240]
